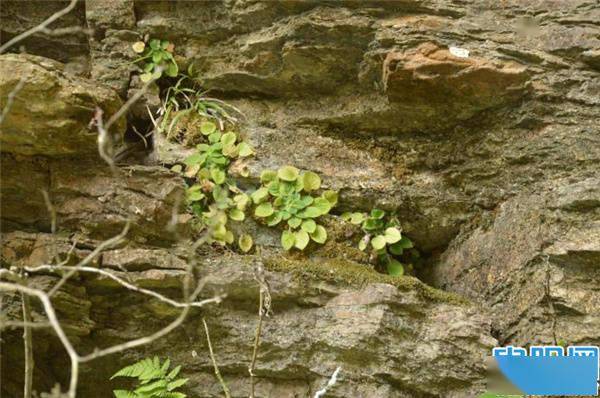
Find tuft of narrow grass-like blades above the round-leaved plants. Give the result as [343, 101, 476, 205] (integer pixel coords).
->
[158, 74, 241, 138]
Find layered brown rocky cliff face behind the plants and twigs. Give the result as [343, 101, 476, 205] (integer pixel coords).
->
[0, 0, 600, 397]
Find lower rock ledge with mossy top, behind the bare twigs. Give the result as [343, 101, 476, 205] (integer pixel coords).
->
[2, 233, 495, 398]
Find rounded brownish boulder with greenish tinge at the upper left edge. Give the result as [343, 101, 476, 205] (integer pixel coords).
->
[0, 54, 125, 156]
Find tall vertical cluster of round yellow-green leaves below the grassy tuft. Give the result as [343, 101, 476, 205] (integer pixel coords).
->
[175, 121, 254, 251]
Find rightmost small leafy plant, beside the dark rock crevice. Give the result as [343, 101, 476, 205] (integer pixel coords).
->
[342, 209, 413, 275]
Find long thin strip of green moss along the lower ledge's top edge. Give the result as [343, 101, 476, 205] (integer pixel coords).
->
[263, 255, 469, 305]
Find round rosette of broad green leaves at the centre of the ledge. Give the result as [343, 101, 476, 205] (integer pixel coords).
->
[250, 166, 338, 250]
